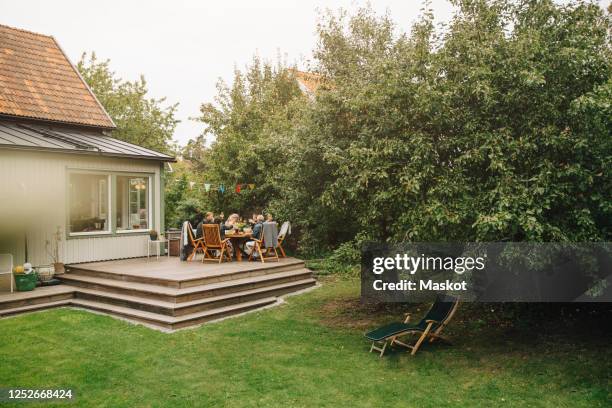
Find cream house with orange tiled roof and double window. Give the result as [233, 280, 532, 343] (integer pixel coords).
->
[0, 25, 174, 276]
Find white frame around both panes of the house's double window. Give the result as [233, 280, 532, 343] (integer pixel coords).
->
[65, 167, 157, 240]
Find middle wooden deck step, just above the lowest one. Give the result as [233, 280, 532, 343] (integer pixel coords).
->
[75, 278, 316, 316]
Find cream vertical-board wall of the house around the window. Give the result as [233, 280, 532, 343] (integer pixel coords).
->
[0, 149, 162, 266]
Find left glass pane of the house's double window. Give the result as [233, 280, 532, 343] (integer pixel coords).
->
[69, 173, 110, 233]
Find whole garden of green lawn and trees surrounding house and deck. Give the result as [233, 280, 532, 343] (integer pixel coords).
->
[0, 0, 612, 407]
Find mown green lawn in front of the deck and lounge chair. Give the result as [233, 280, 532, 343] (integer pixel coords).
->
[0, 278, 612, 407]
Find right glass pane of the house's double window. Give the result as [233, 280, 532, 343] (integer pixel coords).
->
[115, 176, 151, 231]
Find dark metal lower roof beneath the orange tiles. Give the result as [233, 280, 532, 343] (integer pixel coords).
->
[0, 121, 175, 161]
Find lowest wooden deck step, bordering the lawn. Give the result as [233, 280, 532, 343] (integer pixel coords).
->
[71, 297, 277, 329]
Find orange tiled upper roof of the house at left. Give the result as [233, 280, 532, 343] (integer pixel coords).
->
[0, 25, 115, 129]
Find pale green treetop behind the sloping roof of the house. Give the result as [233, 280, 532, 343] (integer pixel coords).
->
[77, 53, 179, 153]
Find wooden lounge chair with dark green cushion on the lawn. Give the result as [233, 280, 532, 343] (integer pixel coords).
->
[365, 295, 459, 357]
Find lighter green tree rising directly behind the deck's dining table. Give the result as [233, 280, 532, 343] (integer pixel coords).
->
[192, 58, 305, 218]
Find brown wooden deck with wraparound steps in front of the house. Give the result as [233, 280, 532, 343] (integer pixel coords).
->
[0, 257, 316, 330]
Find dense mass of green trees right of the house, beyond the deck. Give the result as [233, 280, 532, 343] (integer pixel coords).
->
[179, 0, 612, 257]
